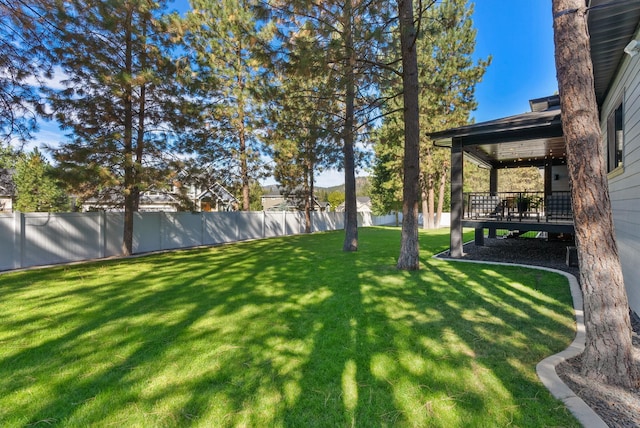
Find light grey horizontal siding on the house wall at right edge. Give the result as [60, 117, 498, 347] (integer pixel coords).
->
[601, 28, 640, 314]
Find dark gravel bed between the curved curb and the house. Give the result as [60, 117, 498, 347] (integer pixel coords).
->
[436, 238, 640, 428]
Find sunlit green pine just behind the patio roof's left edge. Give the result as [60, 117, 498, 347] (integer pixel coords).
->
[418, 0, 491, 228]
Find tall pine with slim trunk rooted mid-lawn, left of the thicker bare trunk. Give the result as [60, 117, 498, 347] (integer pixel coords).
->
[270, 0, 395, 251]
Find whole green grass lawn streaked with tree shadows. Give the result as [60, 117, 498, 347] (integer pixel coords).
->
[0, 228, 579, 427]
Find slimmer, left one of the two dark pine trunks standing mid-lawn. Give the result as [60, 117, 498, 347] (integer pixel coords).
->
[342, 0, 358, 251]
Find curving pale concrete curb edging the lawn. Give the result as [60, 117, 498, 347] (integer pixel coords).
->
[433, 251, 608, 428]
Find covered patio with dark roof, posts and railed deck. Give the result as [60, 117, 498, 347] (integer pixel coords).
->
[430, 95, 574, 257]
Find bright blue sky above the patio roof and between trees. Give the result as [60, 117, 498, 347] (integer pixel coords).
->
[29, 0, 557, 187]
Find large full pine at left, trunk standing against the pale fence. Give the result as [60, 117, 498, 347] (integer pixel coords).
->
[48, 0, 186, 254]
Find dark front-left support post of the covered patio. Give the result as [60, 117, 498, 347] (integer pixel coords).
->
[450, 138, 464, 257]
